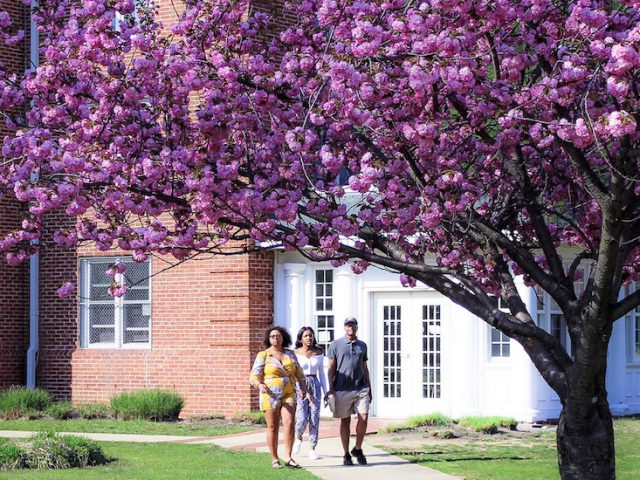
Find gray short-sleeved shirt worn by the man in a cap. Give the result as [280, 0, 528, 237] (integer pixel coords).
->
[327, 337, 369, 391]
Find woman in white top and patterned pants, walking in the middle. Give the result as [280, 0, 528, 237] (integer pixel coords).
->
[293, 327, 327, 460]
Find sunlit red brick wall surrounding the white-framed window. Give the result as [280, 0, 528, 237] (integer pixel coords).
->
[38, 210, 273, 416]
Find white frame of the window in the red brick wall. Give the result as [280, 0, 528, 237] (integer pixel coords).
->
[78, 256, 153, 350]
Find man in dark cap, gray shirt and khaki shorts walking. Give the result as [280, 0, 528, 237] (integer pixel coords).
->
[327, 317, 371, 465]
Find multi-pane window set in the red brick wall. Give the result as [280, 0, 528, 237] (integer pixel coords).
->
[80, 257, 151, 348]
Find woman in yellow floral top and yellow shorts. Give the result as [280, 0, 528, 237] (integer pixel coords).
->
[250, 327, 313, 468]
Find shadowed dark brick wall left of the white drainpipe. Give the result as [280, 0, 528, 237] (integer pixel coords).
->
[0, 0, 29, 390]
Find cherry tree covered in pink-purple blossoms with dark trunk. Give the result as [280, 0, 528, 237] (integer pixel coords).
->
[0, 0, 640, 480]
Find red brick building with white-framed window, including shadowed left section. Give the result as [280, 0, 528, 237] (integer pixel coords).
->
[0, 0, 280, 415]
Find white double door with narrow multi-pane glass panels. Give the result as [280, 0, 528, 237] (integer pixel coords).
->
[371, 292, 446, 418]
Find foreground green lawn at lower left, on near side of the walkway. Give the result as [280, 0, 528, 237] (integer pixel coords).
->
[0, 442, 317, 480]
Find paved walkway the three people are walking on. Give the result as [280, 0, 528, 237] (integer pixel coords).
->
[0, 418, 457, 480]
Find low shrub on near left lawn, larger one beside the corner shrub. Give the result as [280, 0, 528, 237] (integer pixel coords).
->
[24, 432, 109, 470]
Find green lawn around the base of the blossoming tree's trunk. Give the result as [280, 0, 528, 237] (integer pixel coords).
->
[389, 418, 640, 480]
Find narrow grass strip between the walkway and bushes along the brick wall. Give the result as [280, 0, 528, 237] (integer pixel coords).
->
[0, 419, 254, 437]
